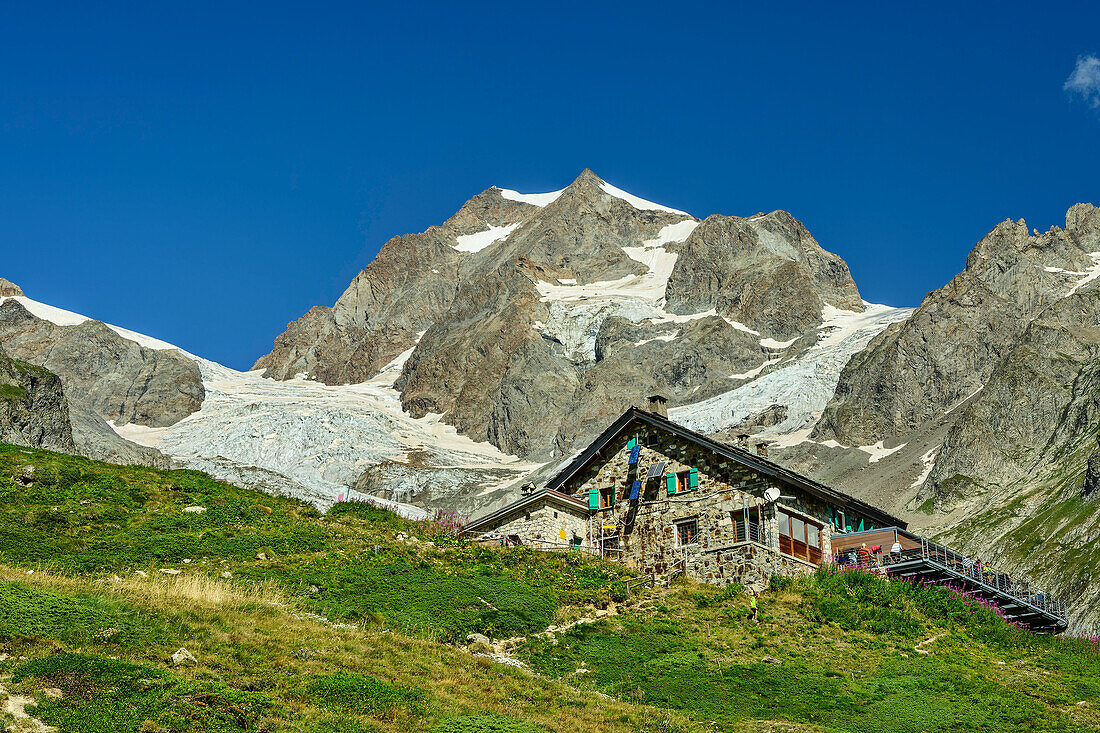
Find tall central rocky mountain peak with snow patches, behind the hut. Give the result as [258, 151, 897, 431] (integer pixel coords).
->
[256, 168, 880, 457]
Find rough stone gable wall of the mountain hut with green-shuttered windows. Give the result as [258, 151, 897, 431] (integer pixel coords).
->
[565, 426, 831, 588]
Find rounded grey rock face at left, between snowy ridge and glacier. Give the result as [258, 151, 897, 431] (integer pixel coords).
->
[0, 300, 205, 427]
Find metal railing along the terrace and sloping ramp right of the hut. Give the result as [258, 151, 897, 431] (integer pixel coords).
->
[853, 537, 1066, 619]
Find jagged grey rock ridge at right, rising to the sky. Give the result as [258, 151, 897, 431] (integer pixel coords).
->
[814, 204, 1100, 445]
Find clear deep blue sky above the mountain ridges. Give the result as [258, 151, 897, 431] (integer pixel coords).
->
[0, 2, 1100, 368]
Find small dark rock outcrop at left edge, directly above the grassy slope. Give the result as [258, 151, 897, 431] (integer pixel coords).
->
[0, 348, 76, 452]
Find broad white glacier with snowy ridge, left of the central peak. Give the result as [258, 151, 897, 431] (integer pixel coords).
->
[4, 296, 538, 518]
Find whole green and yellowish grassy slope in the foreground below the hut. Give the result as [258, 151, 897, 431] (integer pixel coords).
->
[0, 446, 1100, 733]
